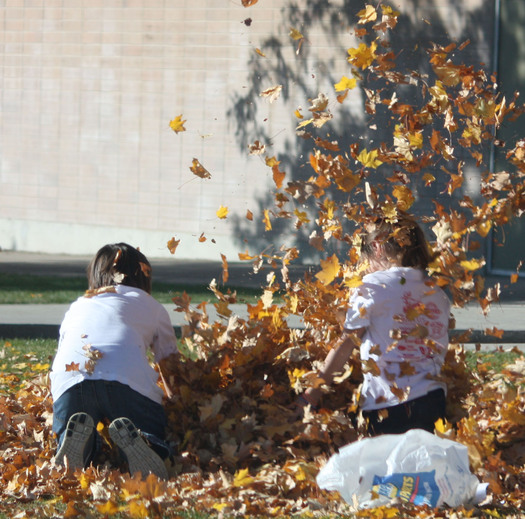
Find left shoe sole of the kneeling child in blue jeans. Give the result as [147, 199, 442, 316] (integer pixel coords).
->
[55, 413, 94, 470]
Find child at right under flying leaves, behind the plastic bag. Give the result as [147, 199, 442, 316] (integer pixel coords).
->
[299, 214, 450, 435]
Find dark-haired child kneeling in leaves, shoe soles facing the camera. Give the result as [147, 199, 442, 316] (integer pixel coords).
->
[50, 243, 178, 479]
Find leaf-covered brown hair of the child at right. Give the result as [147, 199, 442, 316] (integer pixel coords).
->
[361, 213, 434, 270]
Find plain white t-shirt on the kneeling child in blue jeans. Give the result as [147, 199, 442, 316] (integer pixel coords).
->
[50, 285, 177, 403]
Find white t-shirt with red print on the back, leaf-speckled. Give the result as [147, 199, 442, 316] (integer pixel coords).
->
[344, 267, 450, 411]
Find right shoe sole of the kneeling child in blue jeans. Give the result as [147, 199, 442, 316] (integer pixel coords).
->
[109, 417, 168, 479]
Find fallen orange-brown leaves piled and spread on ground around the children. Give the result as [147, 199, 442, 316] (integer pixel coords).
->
[0, 282, 525, 517]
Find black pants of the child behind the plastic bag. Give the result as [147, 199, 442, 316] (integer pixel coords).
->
[363, 389, 446, 436]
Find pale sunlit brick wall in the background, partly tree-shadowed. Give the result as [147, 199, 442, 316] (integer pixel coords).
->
[0, 0, 493, 259]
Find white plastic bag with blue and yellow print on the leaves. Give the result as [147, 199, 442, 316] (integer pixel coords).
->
[317, 429, 487, 508]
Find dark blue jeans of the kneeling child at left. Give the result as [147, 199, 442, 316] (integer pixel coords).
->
[53, 380, 171, 458]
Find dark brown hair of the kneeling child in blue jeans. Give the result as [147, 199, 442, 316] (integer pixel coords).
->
[87, 243, 151, 294]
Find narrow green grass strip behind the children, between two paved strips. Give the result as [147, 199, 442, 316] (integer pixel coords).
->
[0, 273, 261, 304]
